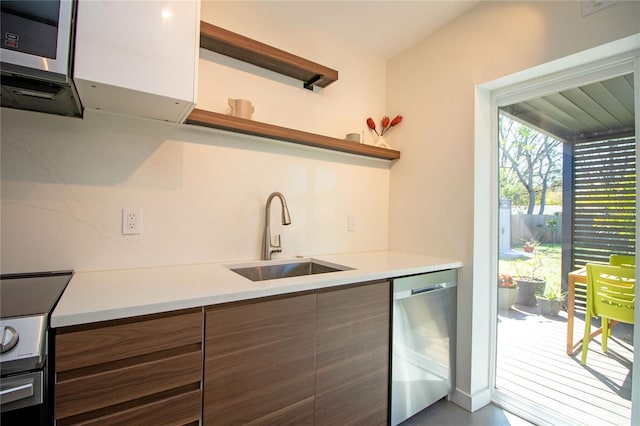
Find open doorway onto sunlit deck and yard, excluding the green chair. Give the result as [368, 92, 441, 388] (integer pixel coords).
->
[494, 70, 637, 425]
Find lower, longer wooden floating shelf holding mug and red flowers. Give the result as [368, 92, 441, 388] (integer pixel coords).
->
[185, 109, 400, 160]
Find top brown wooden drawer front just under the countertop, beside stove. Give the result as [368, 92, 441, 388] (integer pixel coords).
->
[55, 312, 203, 371]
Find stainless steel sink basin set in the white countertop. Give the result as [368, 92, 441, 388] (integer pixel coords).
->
[228, 259, 353, 281]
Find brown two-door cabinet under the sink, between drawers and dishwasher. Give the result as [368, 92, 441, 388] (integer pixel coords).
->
[204, 281, 390, 425]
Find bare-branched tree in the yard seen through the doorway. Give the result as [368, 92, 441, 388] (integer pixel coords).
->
[499, 114, 562, 214]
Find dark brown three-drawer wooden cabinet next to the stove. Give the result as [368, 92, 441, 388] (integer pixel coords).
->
[55, 309, 203, 425]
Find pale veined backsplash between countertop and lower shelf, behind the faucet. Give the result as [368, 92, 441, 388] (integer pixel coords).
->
[1, 109, 389, 273]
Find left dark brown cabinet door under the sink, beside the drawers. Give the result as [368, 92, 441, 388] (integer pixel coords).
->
[204, 292, 316, 425]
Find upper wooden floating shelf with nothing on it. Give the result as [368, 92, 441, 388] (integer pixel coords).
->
[200, 21, 338, 90]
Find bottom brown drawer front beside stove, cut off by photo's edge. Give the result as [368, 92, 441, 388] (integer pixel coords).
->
[60, 390, 201, 426]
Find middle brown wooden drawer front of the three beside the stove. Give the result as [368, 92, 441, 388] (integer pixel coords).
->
[55, 351, 202, 419]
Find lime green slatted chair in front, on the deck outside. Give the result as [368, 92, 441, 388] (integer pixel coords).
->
[581, 263, 636, 365]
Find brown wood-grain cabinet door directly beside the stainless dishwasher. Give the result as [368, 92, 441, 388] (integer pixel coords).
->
[315, 281, 391, 425]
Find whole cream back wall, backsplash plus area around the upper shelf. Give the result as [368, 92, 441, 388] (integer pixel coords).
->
[0, 2, 391, 273]
